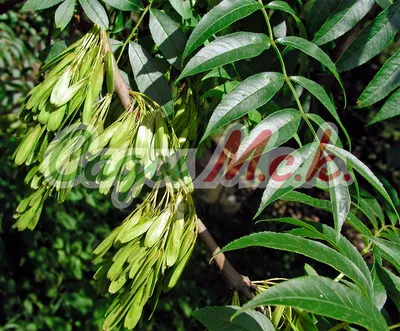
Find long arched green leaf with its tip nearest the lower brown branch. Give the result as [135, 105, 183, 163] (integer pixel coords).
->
[222, 232, 372, 296]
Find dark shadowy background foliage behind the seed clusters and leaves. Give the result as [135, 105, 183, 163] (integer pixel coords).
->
[0, 1, 400, 331]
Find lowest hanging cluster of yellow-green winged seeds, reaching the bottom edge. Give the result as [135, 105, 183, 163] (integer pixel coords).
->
[94, 188, 197, 330]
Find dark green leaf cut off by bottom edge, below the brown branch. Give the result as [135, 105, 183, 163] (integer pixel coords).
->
[192, 306, 275, 331]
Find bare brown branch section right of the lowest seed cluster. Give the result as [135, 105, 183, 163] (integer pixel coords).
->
[197, 218, 254, 300]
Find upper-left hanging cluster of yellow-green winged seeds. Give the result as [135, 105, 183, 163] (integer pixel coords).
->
[14, 27, 113, 230]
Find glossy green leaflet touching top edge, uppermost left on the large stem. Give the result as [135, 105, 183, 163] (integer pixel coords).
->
[183, 0, 262, 59]
